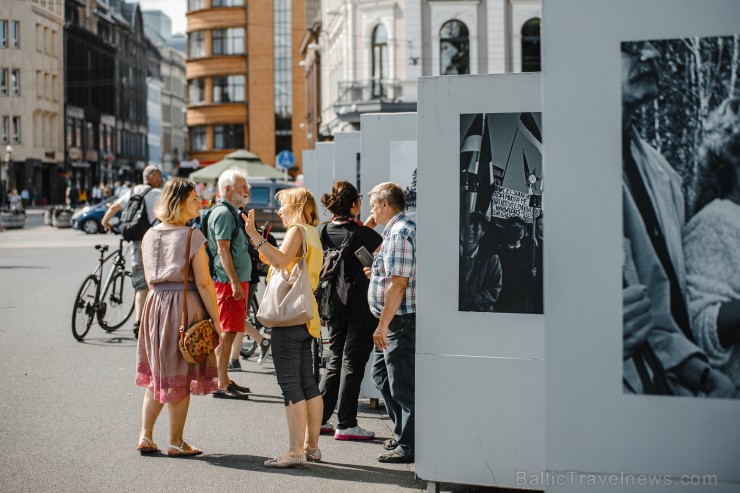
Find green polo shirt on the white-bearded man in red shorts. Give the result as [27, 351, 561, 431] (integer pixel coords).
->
[208, 199, 252, 283]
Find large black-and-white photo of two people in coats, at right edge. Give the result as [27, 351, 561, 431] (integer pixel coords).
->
[620, 34, 740, 398]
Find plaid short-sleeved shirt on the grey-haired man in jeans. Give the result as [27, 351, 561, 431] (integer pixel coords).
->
[367, 212, 416, 318]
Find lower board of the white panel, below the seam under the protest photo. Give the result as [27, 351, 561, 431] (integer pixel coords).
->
[416, 354, 545, 489]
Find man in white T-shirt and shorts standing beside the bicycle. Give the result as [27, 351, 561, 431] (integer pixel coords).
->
[100, 164, 163, 339]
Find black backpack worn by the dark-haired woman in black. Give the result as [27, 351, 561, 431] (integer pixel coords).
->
[314, 227, 357, 322]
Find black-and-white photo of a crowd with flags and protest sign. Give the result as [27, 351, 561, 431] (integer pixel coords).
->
[458, 112, 544, 314]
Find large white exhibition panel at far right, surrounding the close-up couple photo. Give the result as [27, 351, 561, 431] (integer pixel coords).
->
[540, 0, 740, 491]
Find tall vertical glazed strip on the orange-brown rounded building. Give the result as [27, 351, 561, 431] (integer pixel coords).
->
[273, 0, 293, 154]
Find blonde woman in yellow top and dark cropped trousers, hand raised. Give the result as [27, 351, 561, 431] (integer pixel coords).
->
[243, 187, 324, 468]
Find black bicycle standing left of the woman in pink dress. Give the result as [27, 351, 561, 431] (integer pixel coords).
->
[72, 239, 136, 341]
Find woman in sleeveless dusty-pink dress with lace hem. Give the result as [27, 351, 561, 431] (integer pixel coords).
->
[136, 178, 221, 457]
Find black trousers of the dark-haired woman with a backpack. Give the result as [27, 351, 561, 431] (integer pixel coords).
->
[319, 294, 378, 429]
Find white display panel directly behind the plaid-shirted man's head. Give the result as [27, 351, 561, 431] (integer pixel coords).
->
[360, 113, 416, 219]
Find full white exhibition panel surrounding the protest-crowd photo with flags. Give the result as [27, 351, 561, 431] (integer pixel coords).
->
[416, 74, 549, 487]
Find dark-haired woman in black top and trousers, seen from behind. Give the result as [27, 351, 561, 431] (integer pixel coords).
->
[319, 181, 383, 440]
